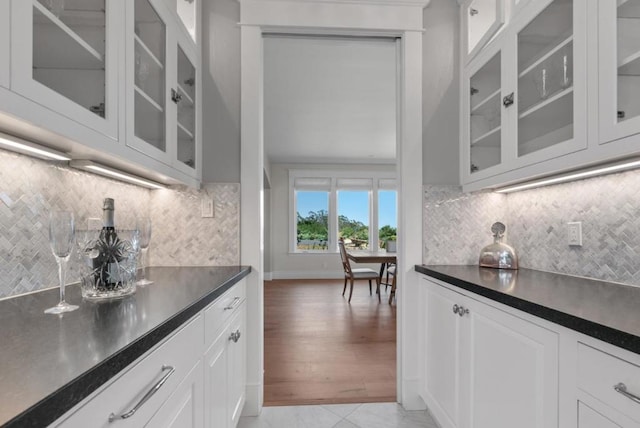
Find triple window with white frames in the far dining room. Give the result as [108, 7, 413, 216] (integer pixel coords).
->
[289, 170, 397, 253]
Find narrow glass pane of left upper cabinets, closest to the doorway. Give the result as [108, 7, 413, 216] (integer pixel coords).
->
[177, 46, 196, 168]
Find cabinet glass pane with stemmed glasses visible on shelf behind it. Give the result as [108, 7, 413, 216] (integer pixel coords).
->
[517, 0, 573, 156]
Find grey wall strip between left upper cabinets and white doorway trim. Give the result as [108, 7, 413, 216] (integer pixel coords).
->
[202, 0, 240, 183]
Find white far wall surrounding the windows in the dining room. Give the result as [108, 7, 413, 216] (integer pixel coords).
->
[265, 164, 395, 279]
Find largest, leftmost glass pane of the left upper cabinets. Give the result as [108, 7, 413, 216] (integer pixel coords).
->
[32, 0, 106, 117]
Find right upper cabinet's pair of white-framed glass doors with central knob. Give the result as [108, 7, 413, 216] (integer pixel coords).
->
[461, 0, 587, 184]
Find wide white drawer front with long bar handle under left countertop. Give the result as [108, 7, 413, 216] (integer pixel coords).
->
[59, 315, 204, 428]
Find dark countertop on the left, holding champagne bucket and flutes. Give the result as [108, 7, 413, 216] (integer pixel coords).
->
[0, 266, 251, 427]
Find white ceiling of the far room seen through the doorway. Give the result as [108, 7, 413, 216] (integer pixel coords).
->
[264, 35, 397, 164]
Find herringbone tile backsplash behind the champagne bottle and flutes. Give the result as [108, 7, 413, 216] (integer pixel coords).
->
[0, 150, 240, 297]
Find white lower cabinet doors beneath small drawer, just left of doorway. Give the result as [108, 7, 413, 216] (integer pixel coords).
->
[204, 303, 246, 428]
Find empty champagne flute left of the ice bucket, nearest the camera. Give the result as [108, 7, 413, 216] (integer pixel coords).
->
[44, 211, 78, 314]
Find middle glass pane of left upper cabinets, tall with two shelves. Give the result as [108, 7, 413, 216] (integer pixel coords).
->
[134, 0, 166, 151]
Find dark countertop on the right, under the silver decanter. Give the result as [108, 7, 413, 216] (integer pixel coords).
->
[415, 265, 640, 354]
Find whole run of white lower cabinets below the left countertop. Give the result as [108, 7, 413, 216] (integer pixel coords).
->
[51, 280, 246, 428]
